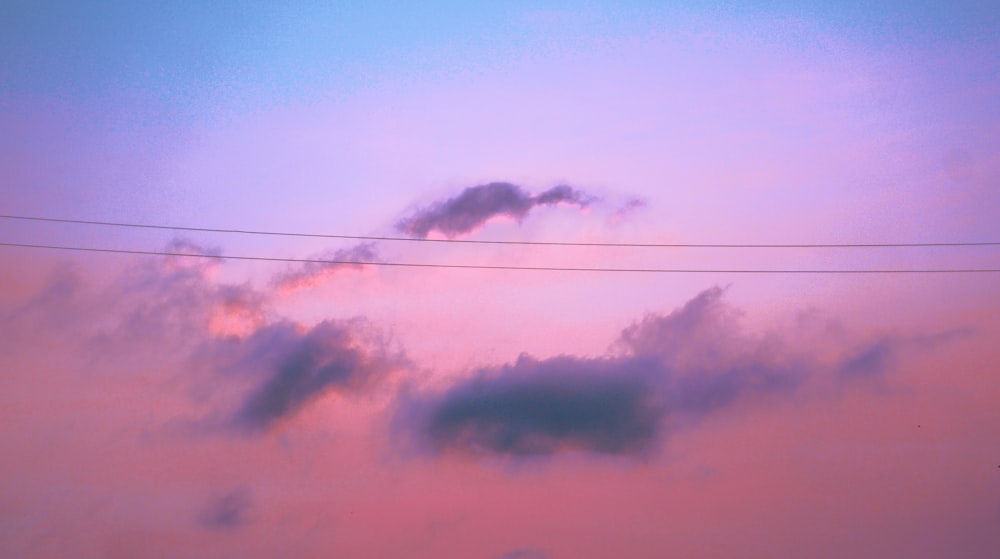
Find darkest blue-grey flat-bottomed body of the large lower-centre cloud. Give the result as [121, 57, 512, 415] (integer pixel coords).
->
[414, 357, 665, 455]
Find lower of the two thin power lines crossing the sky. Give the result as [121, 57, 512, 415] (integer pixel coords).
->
[0, 242, 1000, 274]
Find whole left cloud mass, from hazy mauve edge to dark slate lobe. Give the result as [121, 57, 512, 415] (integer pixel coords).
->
[0, 241, 405, 433]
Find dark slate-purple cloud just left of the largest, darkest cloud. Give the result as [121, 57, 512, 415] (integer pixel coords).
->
[212, 319, 403, 432]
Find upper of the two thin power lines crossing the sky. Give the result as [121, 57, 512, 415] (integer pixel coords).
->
[0, 215, 1000, 248]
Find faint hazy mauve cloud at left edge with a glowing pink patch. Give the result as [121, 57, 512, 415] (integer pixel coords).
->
[0, 239, 268, 360]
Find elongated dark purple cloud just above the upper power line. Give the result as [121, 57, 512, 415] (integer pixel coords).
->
[396, 182, 591, 239]
